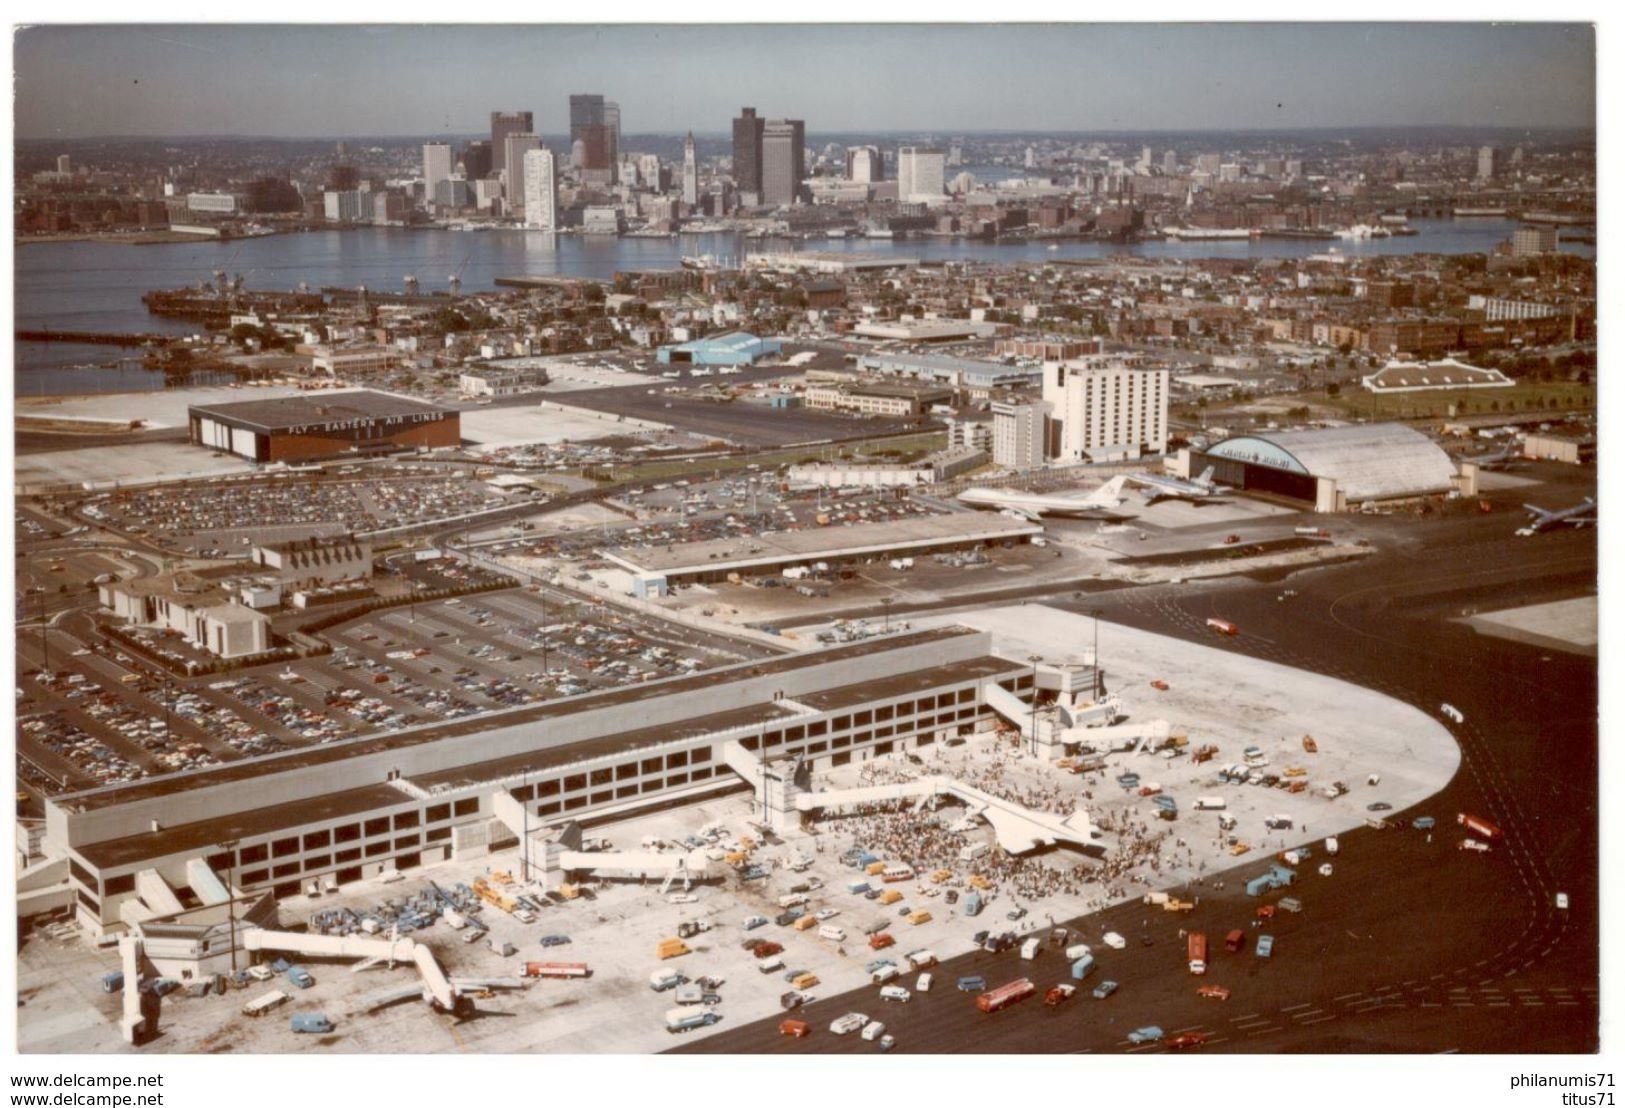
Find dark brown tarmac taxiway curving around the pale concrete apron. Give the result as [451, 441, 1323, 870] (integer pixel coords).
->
[678, 494, 1599, 1053]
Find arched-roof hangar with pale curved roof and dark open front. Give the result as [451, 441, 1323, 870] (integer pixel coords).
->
[1178, 422, 1477, 512]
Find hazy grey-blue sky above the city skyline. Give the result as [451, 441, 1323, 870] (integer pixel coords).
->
[15, 24, 1596, 138]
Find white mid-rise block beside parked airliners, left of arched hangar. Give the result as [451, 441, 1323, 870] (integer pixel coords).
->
[1043, 357, 1168, 461]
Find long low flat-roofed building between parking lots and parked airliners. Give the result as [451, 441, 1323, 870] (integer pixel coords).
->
[601, 512, 1043, 585]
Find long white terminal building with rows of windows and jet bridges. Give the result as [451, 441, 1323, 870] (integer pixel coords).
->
[54, 627, 1034, 936]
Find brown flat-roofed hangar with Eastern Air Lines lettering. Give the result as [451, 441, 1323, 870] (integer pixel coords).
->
[187, 388, 462, 463]
